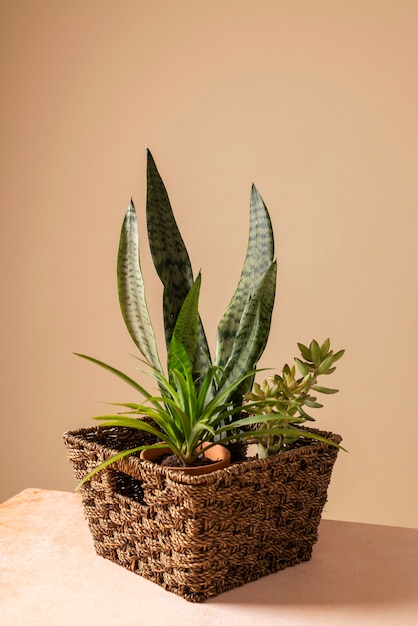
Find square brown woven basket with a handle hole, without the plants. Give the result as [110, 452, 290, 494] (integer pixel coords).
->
[64, 427, 341, 602]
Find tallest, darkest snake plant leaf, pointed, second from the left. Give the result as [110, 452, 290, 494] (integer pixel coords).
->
[146, 150, 211, 372]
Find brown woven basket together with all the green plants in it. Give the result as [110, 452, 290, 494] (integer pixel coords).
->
[64, 151, 343, 601]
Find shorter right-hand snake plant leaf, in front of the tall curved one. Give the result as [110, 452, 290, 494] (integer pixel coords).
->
[216, 261, 277, 395]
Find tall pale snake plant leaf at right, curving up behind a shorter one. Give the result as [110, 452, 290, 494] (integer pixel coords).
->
[215, 184, 274, 367]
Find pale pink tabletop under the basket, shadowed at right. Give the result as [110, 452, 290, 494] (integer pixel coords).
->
[0, 489, 418, 626]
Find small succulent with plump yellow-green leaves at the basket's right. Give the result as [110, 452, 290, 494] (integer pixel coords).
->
[243, 339, 344, 458]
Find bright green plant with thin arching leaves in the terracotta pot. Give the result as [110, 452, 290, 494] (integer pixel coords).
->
[78, 275, 254, 486]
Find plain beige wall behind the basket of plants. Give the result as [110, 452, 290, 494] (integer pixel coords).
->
[0, 0, 418, 526]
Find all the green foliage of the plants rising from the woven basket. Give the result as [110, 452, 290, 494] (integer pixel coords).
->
[78, 151, 343, 484]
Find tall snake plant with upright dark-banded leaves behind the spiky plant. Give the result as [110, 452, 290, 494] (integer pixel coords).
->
[118, 150, 277, 404]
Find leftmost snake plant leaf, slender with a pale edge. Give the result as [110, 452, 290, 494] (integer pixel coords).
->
[117, 200, 161, 371]
